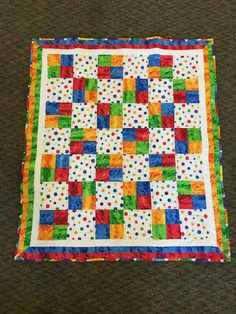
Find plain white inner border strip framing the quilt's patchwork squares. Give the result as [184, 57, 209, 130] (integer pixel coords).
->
[30, 48, 217, 247]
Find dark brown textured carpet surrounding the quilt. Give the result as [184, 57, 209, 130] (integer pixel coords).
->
[0, 0, 236, 314]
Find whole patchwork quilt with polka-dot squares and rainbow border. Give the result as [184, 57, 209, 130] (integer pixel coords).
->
[15, 37, 230, 262]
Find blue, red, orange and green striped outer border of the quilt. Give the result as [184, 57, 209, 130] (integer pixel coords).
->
[15, 37, 230, 262]
